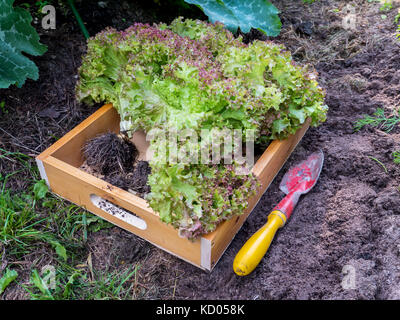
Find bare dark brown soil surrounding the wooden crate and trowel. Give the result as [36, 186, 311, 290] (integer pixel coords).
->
[0, 0, 400, 299]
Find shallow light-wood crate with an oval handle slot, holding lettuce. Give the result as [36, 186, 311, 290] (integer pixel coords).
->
[36, 104, 309, 271]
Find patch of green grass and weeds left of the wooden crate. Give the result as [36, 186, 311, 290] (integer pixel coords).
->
[0, 149, 148, 300]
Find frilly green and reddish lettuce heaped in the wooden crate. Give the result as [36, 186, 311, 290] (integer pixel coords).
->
[76, 18, 327, 238]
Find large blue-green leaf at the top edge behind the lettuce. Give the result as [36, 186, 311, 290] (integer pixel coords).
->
[185, 0, 282, 36]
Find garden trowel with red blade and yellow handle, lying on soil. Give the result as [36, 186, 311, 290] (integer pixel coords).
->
[233, 151, 324, 276]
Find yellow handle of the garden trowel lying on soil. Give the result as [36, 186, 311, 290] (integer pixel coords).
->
[233, 210, 286, 276]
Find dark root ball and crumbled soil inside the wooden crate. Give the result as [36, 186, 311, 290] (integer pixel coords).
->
[81, 132, 151, 197]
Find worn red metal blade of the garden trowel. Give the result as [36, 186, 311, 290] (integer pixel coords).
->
[279, 151, 324, 194]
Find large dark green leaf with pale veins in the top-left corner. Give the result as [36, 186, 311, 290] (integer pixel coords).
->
[0, 0, 47, 89]
